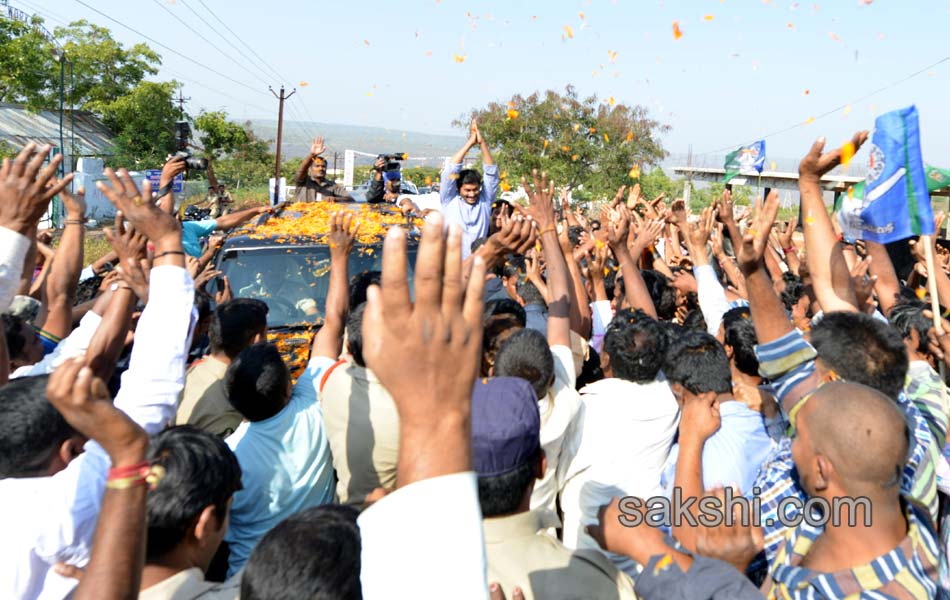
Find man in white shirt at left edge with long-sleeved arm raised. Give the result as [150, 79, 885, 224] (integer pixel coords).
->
[0, 162, 194, 598]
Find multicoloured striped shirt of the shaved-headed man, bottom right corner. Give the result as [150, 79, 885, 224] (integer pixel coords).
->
[767, 503, 939, 600]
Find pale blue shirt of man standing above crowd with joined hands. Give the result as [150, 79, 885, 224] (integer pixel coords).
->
[439, 162, 500, 260]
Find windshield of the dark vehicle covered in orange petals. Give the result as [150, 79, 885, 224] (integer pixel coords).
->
[218, 244, 416, 328]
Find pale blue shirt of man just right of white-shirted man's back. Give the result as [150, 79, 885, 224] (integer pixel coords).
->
[663, 400, 773, 496]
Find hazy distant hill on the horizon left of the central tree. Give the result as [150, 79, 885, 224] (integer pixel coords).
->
[250, 120, 465, 166]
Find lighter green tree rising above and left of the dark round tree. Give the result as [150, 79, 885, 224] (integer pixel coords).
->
[53, 19, 161, 113]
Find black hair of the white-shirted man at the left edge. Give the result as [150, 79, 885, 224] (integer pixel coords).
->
[0, 375, 76, 479]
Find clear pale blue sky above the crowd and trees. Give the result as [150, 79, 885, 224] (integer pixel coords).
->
[26, 0, 950, 166]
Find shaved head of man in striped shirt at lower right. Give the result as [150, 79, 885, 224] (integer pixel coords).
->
[798, 382, 908, 494]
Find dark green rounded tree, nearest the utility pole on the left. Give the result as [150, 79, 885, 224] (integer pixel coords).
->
[101, 81, 178, 169]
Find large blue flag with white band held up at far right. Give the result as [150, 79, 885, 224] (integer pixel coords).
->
[838, 106, 934, 244]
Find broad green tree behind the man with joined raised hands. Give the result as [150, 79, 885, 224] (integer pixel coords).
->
[454, 86, 669, 197]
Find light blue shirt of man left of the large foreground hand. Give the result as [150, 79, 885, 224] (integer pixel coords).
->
[224, 356, 336, 577]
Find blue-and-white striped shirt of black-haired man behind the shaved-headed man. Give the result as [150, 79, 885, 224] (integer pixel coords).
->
[753, 330, 947, 564]
